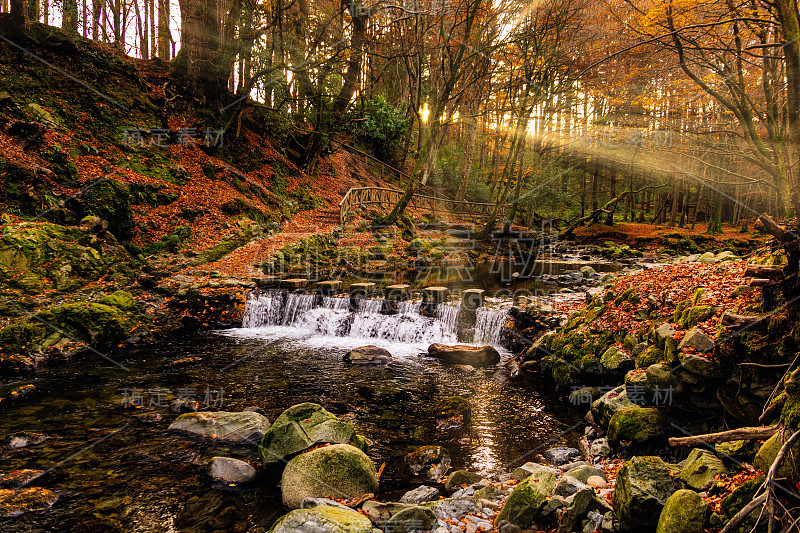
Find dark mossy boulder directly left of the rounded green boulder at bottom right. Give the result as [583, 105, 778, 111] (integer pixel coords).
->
[613, 456, 677, 533]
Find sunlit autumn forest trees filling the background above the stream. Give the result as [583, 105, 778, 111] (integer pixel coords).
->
[0, 0, 800, 233]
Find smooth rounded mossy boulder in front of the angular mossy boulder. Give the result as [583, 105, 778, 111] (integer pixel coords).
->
[281, 444, 378, 509]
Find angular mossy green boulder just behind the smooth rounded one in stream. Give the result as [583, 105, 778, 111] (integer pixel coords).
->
[259, 403, 364, 469]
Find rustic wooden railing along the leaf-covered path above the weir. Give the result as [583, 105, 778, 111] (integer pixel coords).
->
[339, 187, 511, 226]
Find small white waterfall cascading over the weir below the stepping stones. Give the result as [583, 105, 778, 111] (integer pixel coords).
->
[242, 291, 508, 346]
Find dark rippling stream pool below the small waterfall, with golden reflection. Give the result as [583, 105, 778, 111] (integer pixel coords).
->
[0, 332, 578, 532]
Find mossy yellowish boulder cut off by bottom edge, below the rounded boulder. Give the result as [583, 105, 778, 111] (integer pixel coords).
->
[270, 505, 372, 533]
